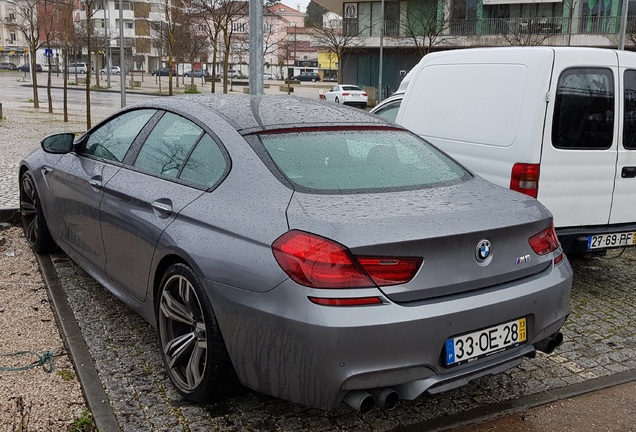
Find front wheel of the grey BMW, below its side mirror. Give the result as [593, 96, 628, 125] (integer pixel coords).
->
[20, 171, 55, 253]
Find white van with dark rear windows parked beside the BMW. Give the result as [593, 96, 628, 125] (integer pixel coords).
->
[386, 47, 636, 253]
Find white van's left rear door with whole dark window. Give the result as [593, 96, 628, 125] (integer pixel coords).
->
[538, 48, 620, 228]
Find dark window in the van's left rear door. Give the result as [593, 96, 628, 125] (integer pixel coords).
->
[552, 68, 614, 150]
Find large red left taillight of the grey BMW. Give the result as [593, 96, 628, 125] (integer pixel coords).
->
[272, 230, 422, 288]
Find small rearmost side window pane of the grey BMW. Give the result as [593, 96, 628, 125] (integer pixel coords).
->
[179, 134, 227, 188]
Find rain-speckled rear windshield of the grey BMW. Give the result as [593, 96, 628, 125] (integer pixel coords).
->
[253, 129, 469, 193]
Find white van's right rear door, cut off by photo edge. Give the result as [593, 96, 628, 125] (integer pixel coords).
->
[610, 52, 636, 224]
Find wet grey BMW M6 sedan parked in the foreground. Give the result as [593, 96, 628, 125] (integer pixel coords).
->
[19, 94, 572, 412]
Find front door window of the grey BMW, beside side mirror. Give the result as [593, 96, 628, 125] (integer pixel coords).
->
[83, 109, 156, 162]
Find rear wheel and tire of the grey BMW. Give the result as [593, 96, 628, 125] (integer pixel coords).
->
[157, 263, 235, 403]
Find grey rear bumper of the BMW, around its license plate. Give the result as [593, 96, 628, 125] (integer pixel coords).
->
[206, 260, 572, 409]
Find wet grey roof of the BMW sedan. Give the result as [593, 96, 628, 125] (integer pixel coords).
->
[130, 94, 396, 135]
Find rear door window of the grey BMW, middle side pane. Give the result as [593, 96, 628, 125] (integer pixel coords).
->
[135, 113, 203, 178]
